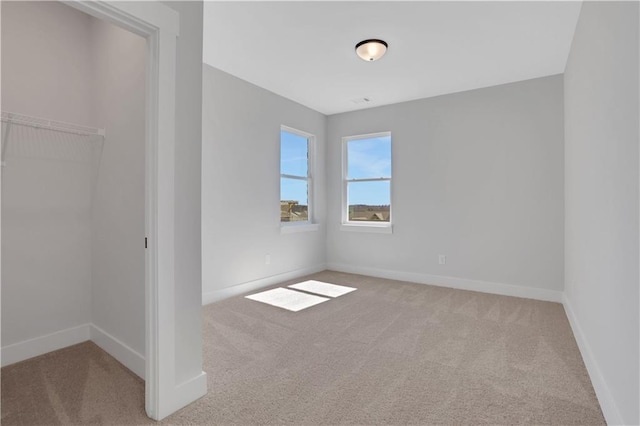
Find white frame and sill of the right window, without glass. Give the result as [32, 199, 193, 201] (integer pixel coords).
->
[340, 132, 393, 234]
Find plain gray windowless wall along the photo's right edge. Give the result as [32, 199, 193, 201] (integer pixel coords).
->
[564, 2, 640, 424]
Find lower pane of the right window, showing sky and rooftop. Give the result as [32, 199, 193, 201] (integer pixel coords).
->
[347, 181, 391, 222]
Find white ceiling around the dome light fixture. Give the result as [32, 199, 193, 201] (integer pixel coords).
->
[204, 1, 581, 114]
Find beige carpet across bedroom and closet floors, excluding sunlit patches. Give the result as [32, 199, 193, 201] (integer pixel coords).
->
[2, 271, 604, 426]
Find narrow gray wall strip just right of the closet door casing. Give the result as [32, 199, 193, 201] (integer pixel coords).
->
[165, 1, 202, 384]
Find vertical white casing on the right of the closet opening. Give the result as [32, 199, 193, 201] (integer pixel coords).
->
[145, 27, 178, 420]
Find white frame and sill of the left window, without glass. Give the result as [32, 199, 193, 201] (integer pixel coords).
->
[278, 124, 319, 234]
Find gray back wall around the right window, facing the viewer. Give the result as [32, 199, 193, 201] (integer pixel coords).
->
[327, 76, 564, 295]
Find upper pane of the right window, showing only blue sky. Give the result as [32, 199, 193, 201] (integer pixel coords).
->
[347, 136, 391, 179]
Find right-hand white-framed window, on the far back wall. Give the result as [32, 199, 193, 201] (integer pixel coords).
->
[342, 132, 391, 232]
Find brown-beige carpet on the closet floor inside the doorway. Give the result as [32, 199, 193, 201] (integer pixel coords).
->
[1, 342, 153, 426]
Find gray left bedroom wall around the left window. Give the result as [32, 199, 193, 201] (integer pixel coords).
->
[202, 64, 326, 302]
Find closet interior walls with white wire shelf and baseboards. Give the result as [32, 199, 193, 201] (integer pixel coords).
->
[0, 2, 146, 376]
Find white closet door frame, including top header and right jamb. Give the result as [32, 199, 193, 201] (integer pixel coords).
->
[63, 0, 181, 420]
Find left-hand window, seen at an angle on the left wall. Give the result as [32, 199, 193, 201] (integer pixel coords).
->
[280, 126, 314, 225]
